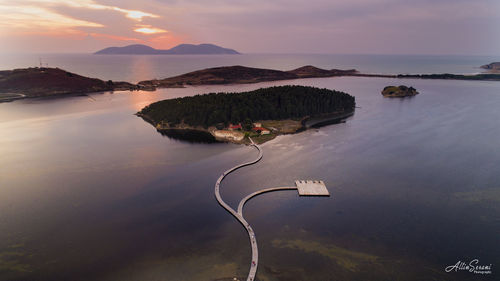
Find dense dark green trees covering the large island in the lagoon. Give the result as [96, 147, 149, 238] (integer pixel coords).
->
[139, 86, 355, 128]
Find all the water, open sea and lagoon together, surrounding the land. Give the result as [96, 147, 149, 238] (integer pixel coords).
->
[0, 54, 500, 281]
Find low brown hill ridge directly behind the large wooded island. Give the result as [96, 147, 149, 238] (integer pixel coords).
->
[139, 65, 357, 88]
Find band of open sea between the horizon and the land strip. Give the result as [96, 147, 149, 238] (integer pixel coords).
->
[0, 54, 500, 83]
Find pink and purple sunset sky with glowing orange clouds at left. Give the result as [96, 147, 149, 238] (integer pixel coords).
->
[0, 0, 500, 55]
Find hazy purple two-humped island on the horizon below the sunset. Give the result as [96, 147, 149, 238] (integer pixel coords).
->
[94, 44, 240, 55]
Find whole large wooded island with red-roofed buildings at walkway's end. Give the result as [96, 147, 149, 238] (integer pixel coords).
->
[137, 86, 356, 143]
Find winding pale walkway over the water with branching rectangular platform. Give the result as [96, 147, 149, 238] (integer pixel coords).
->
[215, 138, 330, 281]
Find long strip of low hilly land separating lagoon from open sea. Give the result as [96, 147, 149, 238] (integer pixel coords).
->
[0, 66, 500, 103]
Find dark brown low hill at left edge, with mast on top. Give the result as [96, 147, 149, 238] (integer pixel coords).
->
[0, 67, 137, 97]
